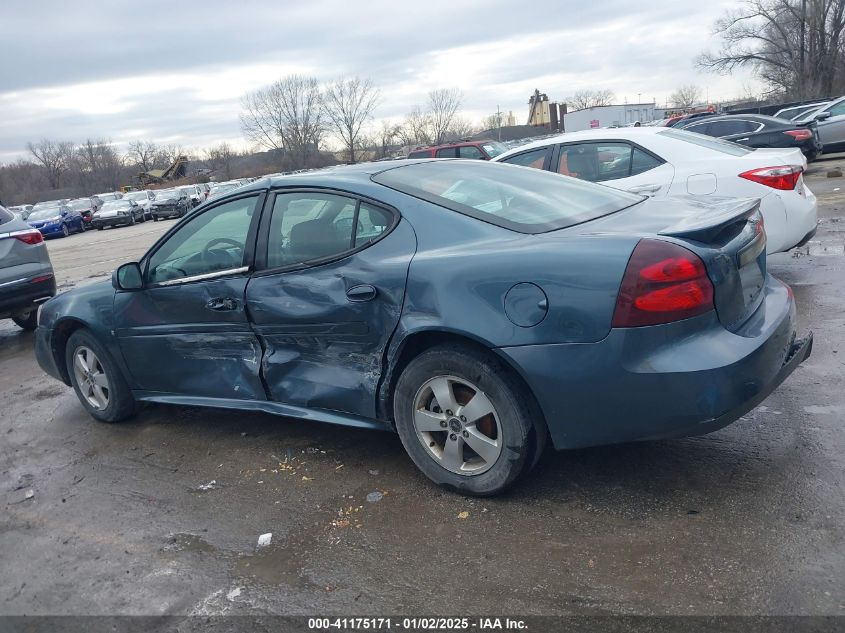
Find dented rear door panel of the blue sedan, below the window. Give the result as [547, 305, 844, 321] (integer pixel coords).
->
[247, 221, 416, 418]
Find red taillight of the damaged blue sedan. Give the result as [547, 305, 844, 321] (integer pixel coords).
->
[613, 240, 713, 327]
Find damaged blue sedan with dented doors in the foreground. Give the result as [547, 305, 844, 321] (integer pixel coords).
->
[36, 160, 812, 495]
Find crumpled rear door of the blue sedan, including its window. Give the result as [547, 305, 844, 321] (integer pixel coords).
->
[246, 189, 416, 418]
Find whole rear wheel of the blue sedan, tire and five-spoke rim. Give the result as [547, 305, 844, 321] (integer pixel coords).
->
[393, 346, 545, 496]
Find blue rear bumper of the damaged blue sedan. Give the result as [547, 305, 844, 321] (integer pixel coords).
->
[498, 276, 812, 449]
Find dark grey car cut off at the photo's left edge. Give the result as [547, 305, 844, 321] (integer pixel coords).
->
[0, 207, 56, 330]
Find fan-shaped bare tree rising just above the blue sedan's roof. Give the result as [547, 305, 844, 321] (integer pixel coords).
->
[323, 77, 380, 163]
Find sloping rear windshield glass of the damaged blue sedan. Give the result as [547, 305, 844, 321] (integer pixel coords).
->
[372, 160, 644, 233]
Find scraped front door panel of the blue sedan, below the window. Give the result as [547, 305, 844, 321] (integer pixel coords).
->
[114, 276, 266, 400]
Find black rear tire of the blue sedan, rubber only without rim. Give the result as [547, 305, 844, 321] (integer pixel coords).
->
[393, 345, 545, 496]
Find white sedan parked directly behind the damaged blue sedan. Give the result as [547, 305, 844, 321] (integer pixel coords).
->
[493, 127, 817, 253]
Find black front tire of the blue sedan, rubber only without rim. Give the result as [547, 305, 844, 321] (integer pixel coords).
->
[65, 330, 135, 422]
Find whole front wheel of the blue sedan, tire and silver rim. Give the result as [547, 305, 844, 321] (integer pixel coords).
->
[65, 330, 135, 422]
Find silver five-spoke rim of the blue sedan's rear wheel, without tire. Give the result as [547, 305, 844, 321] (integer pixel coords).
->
[413, 375, 503, 475]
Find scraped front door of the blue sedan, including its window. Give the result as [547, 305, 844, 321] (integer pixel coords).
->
[114, 192, 266, 400]
